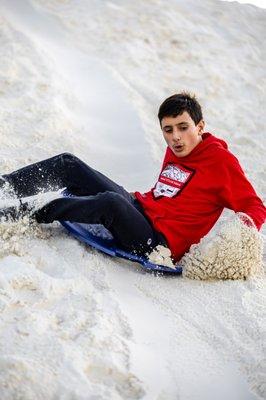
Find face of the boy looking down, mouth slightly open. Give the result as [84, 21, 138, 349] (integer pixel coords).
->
[161, 111, 205, 157]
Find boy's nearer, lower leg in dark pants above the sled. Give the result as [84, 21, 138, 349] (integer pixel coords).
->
[34, 192, 160, 253]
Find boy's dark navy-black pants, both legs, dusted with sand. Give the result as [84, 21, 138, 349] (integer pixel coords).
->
[3, 153, 166, 253]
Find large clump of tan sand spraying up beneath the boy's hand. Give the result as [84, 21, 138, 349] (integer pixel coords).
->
[180, 213, 263, 280]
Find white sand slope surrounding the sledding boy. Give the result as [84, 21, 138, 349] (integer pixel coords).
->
[0, 0, 266, 400]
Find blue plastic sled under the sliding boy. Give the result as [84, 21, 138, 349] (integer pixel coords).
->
[61, 221, 182, 275]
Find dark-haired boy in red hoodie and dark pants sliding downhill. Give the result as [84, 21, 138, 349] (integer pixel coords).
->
[2, 93, 266, 262]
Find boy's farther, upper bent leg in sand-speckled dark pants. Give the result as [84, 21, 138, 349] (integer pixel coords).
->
[3, 153, 130, 199]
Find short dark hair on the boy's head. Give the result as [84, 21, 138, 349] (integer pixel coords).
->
[158, 92, 203, 125]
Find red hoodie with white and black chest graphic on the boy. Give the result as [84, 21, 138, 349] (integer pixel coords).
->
[135, 132, 266, 261]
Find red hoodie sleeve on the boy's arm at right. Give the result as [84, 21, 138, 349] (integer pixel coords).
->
[220, 152, 266, 230]
